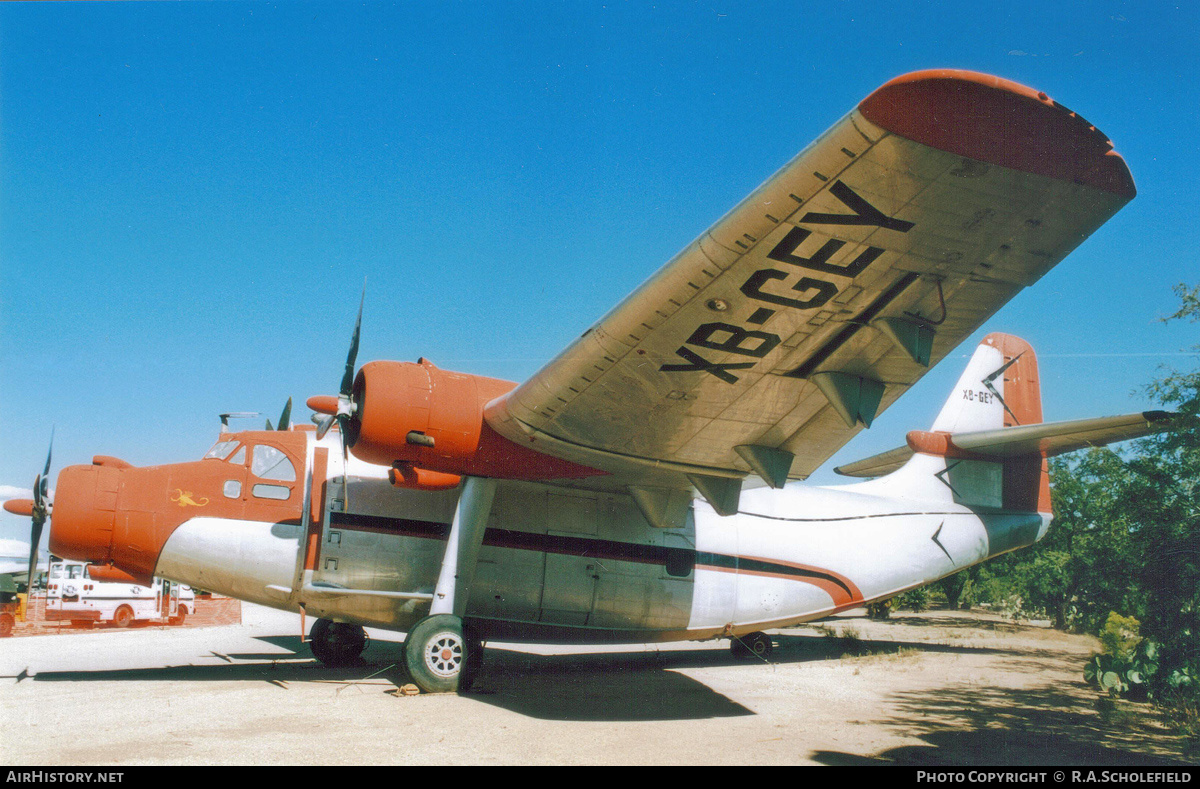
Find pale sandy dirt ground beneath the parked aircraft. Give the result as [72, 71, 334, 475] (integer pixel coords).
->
[0, 606, 1188, 767]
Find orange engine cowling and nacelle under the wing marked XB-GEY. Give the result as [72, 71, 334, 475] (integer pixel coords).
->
[346, 359, 601, 479]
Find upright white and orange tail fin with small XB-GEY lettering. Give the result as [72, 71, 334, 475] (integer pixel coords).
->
[838, 333, 1050, 514]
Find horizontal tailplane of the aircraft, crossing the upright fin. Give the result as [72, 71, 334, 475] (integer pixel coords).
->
[834, 411, 1181, 477]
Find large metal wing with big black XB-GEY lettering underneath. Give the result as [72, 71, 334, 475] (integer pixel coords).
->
[486, 71, 1135, 512]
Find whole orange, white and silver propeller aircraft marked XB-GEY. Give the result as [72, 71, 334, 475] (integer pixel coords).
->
[8, 71, 1172, 692]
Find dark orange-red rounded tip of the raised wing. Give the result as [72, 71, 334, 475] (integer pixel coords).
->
[858, 68, 1138, 200]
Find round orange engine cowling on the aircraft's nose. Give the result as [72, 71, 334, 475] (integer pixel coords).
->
[50, 465, 121, 564]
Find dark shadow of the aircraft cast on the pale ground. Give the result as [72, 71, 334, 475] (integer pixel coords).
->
[9, 633, 1036, 722]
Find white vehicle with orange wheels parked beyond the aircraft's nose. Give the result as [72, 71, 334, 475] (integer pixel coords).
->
[46, 561, 196, 627]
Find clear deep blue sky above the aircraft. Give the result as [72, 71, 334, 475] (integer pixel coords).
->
[0, 0, 1200, 537]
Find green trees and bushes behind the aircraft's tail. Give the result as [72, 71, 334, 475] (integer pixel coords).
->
[972, 280, 1200, 657]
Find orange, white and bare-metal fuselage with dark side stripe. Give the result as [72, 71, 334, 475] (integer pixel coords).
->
[52, 428, 1049, 643]
